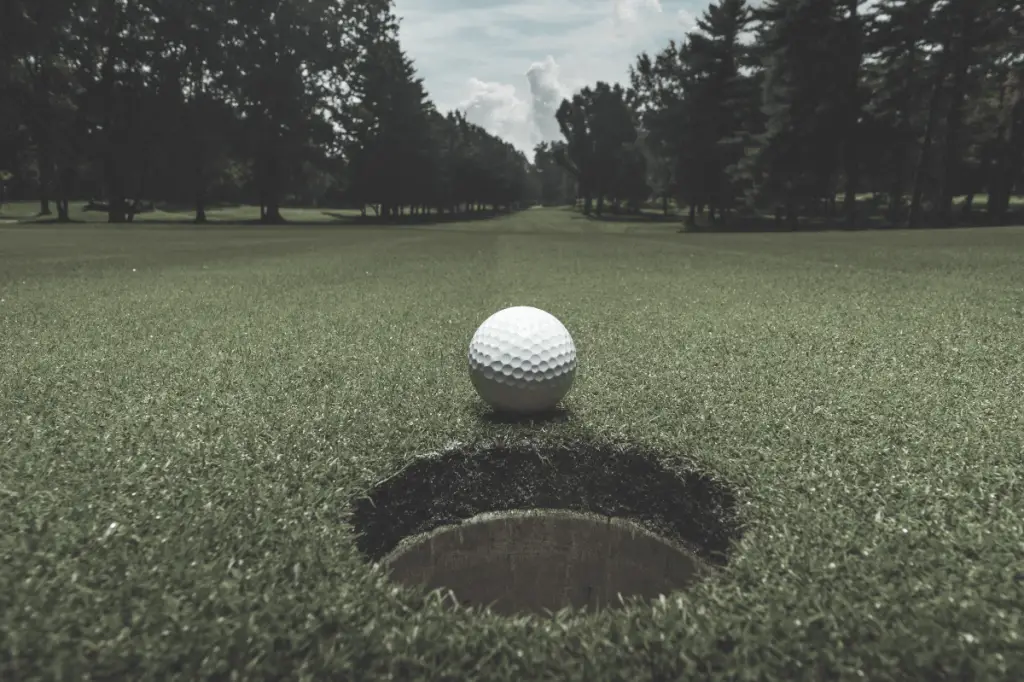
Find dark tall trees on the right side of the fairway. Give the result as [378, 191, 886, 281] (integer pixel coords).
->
[537, 0, 1024, 226]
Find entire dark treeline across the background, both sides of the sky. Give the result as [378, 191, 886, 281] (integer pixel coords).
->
[0, 0, 1024, 226]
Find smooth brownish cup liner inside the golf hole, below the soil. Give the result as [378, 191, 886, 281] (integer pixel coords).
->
[383, 510, 711, 615]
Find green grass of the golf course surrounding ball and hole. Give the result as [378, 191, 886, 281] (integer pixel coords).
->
[0, 210, 1024, 682]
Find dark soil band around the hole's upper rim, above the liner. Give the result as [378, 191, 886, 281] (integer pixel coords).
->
[351, 442, 737, 565]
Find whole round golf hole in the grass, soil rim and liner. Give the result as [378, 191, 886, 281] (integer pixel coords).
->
[352, 441, 738, 615]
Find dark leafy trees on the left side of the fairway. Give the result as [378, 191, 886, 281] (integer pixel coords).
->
[0, 0, 540, 222]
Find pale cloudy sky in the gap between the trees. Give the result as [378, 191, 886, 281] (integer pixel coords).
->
[395, 0, 709, 158]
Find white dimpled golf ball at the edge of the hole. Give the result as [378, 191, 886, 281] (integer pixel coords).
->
[469, 305, 577, 414]
